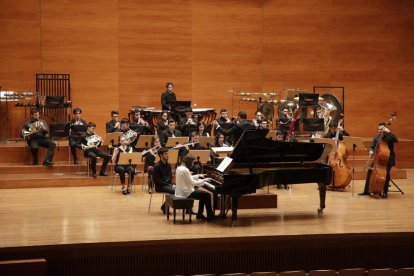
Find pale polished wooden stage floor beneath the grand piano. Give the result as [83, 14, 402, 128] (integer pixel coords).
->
[0, 169, 414, 249]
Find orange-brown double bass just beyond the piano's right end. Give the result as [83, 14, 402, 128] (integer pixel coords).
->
[328, 114, 352, 189]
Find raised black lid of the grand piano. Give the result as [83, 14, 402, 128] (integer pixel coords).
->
[230, 130, 331, 164]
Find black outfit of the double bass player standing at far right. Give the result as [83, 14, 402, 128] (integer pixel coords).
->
[360, 132, 398, 198]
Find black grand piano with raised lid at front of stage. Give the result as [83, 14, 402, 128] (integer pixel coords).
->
[203, 130, 332, 222]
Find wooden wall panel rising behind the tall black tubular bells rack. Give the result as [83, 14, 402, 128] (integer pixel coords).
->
[41, 0, 119, 134]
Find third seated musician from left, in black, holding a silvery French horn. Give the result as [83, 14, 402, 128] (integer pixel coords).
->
[81, 122, 111, 178]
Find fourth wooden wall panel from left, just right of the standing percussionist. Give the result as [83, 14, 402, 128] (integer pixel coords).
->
[192, 0, 262, 116]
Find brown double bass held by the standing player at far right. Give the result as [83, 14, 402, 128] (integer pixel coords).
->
[369, 112, 397, 194]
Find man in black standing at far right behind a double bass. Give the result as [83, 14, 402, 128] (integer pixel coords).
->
[359, 123, 398, 198]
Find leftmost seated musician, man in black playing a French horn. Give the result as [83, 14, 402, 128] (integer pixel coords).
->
[22, 109, 56, 167]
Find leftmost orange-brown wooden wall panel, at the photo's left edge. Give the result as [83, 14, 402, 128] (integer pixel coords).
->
[0, 0, 40, 138]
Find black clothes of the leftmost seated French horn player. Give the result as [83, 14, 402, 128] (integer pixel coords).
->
[23, 119, 56, 166]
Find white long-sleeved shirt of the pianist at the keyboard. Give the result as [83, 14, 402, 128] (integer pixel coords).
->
[175, 165, 207, 197]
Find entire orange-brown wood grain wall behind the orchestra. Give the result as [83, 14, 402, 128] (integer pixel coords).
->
[0, 0, 414, 139]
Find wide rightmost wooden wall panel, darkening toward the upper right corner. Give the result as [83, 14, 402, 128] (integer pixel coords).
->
[263, 0, 414, 139]
